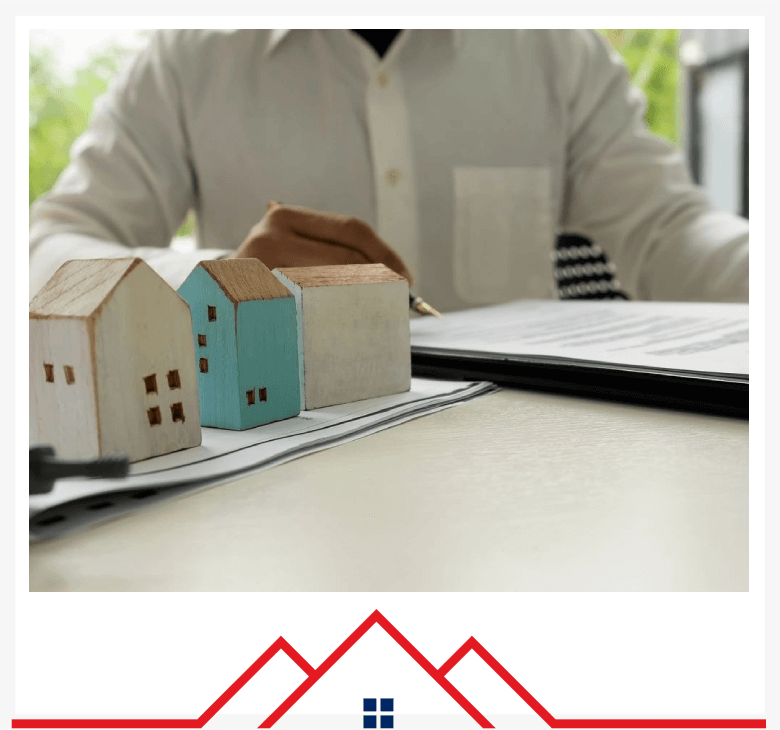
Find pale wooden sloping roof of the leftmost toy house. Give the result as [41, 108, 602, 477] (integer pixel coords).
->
[30, 258, 143, 317]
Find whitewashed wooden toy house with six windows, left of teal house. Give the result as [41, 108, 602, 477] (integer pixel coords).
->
[30, 258, 201, 461]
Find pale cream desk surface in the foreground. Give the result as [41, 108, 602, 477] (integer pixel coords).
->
[30, 390, 749, 591]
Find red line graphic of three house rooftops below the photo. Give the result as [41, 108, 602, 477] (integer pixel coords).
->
[11, 609, 766, 728]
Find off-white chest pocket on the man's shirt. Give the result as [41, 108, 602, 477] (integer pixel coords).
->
[453, 167, 555, 304]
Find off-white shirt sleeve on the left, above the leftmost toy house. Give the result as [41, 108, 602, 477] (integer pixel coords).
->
[29, 31, 235, 297]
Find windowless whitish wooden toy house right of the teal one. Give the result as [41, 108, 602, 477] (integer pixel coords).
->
[274, 264, 411, 410]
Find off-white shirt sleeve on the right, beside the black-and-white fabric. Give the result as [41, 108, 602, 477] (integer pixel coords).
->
[561, 30, 749, 302]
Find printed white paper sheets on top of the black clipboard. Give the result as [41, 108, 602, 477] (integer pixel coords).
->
[411, 300, 750, 381]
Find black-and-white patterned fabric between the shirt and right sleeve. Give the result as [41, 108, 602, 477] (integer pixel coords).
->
[552, 233, 630, 299]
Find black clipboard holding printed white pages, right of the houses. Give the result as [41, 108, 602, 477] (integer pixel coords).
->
[411, 300, 750, 410]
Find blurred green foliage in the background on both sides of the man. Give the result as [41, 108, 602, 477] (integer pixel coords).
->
[29, 29, 680, 236]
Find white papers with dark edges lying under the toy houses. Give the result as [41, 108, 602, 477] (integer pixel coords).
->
[29, 378, 497, 539]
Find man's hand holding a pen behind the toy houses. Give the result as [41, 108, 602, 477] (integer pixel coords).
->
[230, 203, 412, 284]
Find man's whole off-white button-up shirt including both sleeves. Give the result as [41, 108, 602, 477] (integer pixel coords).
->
[30, 29, 749, 311]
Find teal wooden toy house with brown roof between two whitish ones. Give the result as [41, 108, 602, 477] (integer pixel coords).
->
[178, 259, 301, 430]
